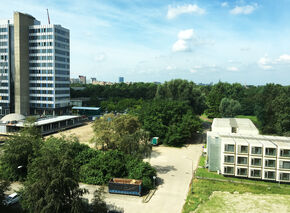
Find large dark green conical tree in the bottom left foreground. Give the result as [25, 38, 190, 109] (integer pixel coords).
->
[20, 137, 86, 212]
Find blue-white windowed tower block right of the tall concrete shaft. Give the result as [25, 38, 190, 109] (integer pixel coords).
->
[29, 24, 70, 114]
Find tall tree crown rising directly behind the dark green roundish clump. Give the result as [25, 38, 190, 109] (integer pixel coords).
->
[156, 79, 205, 115]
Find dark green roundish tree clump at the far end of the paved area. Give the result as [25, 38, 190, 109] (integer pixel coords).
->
[136, 100, 201, 146]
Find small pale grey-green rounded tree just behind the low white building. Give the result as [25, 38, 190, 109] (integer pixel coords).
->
[219, 98, 241, 118]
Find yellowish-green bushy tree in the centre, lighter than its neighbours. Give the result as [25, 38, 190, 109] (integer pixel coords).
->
[92, 114, 151, 157]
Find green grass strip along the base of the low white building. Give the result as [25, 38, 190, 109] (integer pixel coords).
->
[183, 156, 290, 213]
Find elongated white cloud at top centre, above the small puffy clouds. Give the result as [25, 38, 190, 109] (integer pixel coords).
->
[167, 4, 205, 19]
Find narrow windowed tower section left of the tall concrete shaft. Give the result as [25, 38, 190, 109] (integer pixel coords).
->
[0, 20, 14, 114]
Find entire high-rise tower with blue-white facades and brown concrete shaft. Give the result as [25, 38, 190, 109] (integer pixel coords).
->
[0, 12, 70, 115]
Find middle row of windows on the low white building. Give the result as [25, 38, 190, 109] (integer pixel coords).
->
[224, 155, 290, 169]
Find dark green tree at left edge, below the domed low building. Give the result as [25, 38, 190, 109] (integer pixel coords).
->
[0, 123, 42, 181]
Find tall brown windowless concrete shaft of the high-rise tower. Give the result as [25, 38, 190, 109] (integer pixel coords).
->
[14, 12, 35, 115]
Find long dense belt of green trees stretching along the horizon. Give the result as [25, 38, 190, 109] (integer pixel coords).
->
[72, 79, 290, 138]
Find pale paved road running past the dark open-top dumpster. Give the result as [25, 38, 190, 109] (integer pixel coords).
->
[82, 145, 202, 213]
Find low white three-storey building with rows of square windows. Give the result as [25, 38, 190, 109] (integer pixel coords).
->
[207, 118, 290, 182]
